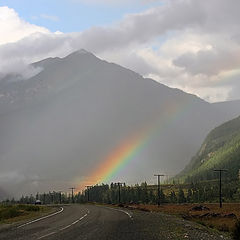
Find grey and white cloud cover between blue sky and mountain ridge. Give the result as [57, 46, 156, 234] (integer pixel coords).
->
[0, 0, 240, 101]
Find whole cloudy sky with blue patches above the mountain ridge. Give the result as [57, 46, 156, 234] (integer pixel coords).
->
[0, 0, 240, 102]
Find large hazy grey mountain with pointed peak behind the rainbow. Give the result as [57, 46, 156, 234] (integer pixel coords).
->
[0, 50, 240, 195]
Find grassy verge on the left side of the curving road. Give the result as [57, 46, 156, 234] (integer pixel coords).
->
[0, 204, 52, 224]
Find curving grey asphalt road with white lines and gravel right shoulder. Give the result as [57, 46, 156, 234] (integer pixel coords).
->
[0, 204, 230, 240]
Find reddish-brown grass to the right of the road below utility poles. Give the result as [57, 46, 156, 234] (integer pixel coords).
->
[124, 203, 240, 233]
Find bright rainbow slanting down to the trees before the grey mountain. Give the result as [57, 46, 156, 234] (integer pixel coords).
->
[79, 99, 192, 190]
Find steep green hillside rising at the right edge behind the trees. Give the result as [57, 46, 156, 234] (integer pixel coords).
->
[178, 117, 240, 181]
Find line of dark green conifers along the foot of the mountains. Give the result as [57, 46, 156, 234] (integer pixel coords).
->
[5, 180, 240, 204]
